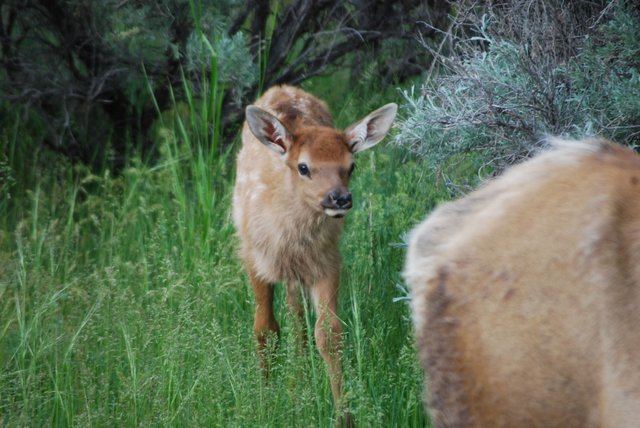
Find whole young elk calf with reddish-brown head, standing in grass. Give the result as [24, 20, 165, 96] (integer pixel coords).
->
[233, 86, 397, 416]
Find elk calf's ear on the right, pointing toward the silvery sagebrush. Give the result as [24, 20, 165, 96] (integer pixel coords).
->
[344, 103, 398, 153]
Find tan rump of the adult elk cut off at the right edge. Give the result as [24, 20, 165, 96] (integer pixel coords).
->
[405, 140, 640, 428]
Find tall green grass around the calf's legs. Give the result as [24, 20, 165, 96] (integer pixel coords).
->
[0, 76, 447, 427]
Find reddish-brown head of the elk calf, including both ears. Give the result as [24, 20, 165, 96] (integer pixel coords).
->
[246, 103, 397, 218]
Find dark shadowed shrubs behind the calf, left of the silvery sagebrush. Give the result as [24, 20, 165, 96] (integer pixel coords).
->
[0, 0, 449, 167]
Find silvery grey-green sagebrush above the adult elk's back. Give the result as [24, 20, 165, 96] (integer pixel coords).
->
[396, 1, 640, 171]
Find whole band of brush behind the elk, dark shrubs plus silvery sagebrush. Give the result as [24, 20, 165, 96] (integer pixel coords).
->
[0, 0, 640, 176]
